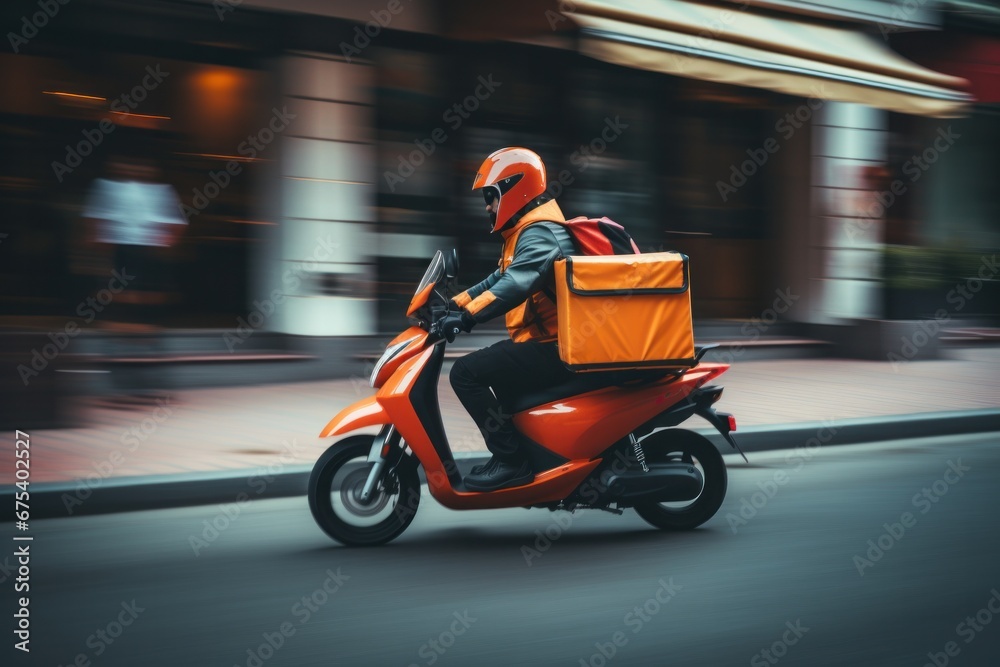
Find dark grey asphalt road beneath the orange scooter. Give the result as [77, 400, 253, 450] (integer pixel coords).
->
[7, 434, 1000, 667]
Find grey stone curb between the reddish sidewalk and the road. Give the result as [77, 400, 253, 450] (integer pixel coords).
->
[9, 409, 1000, 519]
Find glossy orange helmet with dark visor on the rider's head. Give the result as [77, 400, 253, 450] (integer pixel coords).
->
[472, 147, 545, 232]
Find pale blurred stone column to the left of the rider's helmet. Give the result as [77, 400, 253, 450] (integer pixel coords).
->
[264, 55, 376, 336]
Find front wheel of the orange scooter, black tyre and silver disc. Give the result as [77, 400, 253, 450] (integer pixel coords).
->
[308, 435, 420, 546]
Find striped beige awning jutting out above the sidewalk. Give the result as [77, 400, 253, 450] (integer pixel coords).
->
[566, 0, 974, 118]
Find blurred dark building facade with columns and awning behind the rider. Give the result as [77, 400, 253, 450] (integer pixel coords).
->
[0, 0, 985, 344]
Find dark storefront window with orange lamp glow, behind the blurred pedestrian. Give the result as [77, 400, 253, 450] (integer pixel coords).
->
[0, 51, 276, 327]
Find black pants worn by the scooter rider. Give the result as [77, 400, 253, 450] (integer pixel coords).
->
[451, 339, 573, 461]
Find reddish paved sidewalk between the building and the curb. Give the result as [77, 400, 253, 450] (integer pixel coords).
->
[7, 346, 1000, 488]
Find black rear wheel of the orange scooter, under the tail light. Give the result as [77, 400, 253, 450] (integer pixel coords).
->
[635, 429, 729, 530]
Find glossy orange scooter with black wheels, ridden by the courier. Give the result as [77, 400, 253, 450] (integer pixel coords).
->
[308, 251, 746, 545]
